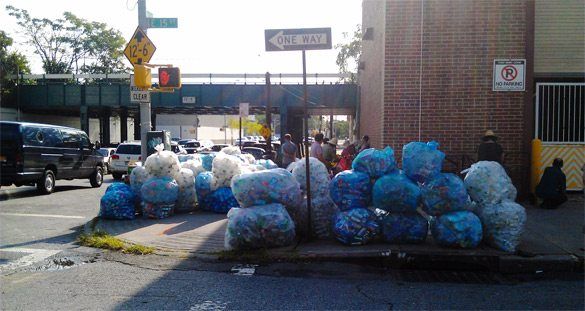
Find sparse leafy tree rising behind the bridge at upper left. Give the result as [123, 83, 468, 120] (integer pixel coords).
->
[6, 6, 127, 73]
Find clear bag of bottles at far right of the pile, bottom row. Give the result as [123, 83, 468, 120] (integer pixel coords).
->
[479, 201, 526, 252]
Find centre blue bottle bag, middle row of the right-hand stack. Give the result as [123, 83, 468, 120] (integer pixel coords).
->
[372, 172, 420, 213]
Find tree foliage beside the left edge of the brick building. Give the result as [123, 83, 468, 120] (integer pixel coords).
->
[335, 24, 362, 83]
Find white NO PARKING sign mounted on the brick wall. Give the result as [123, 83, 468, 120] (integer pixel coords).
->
[492, 59, 526, 91]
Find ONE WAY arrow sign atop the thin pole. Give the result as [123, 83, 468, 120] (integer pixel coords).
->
[264, 28, 331, 51]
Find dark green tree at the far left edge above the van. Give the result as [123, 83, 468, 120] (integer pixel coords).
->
[0, 30, 30, 102]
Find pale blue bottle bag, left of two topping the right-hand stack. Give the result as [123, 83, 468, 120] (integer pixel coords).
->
[351, 147, 396, 178]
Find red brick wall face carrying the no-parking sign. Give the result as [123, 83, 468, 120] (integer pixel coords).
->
[384, 0, 532, 186]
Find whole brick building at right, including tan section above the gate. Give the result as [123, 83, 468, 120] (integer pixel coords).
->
[359, 0, 585, 195]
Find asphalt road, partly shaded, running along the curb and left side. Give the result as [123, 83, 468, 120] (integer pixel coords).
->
[0, 176, 585, 310]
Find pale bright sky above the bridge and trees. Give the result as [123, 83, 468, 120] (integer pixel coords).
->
[0, 0, 362, 74]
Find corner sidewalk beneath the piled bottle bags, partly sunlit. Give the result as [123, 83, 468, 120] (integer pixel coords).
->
[86, 194, 585, 272]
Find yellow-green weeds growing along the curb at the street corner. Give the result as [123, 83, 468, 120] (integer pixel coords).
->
[78, 230, 154, 255]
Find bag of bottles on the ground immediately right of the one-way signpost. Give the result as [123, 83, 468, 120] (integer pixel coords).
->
[303, 194, 339, 240]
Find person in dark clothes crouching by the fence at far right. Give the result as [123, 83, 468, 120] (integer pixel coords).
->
[536, 158, 567, 208]
